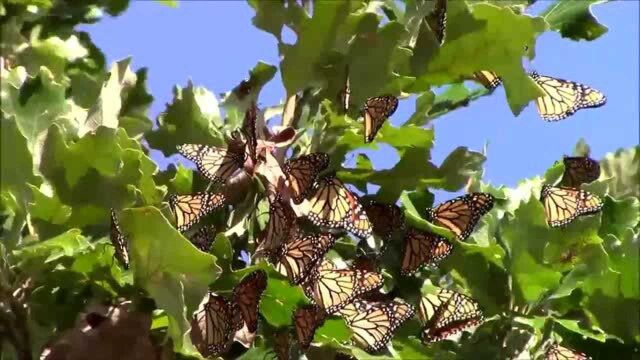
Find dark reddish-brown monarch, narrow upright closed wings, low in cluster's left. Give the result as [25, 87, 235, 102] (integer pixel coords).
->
[233, 270, 267, 333]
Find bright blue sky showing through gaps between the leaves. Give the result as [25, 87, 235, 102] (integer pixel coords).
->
[82, 0, 640, 200]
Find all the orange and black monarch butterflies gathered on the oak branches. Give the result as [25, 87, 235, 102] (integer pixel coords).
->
[104, 4, 606, 360]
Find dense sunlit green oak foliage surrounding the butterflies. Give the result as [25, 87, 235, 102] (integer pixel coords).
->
[0, 0, 640, 359]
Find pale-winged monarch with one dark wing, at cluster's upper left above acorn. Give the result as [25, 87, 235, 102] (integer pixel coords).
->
[178, 133, 246, 184]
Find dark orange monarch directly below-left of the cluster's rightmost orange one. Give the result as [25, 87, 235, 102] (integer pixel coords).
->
[401, 228, 453, 275]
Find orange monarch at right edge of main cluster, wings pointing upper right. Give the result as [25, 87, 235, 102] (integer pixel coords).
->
[427, 193, 494, 240]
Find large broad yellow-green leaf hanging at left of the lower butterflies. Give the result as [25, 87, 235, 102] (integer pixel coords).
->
[120, 207, 220, 356]
